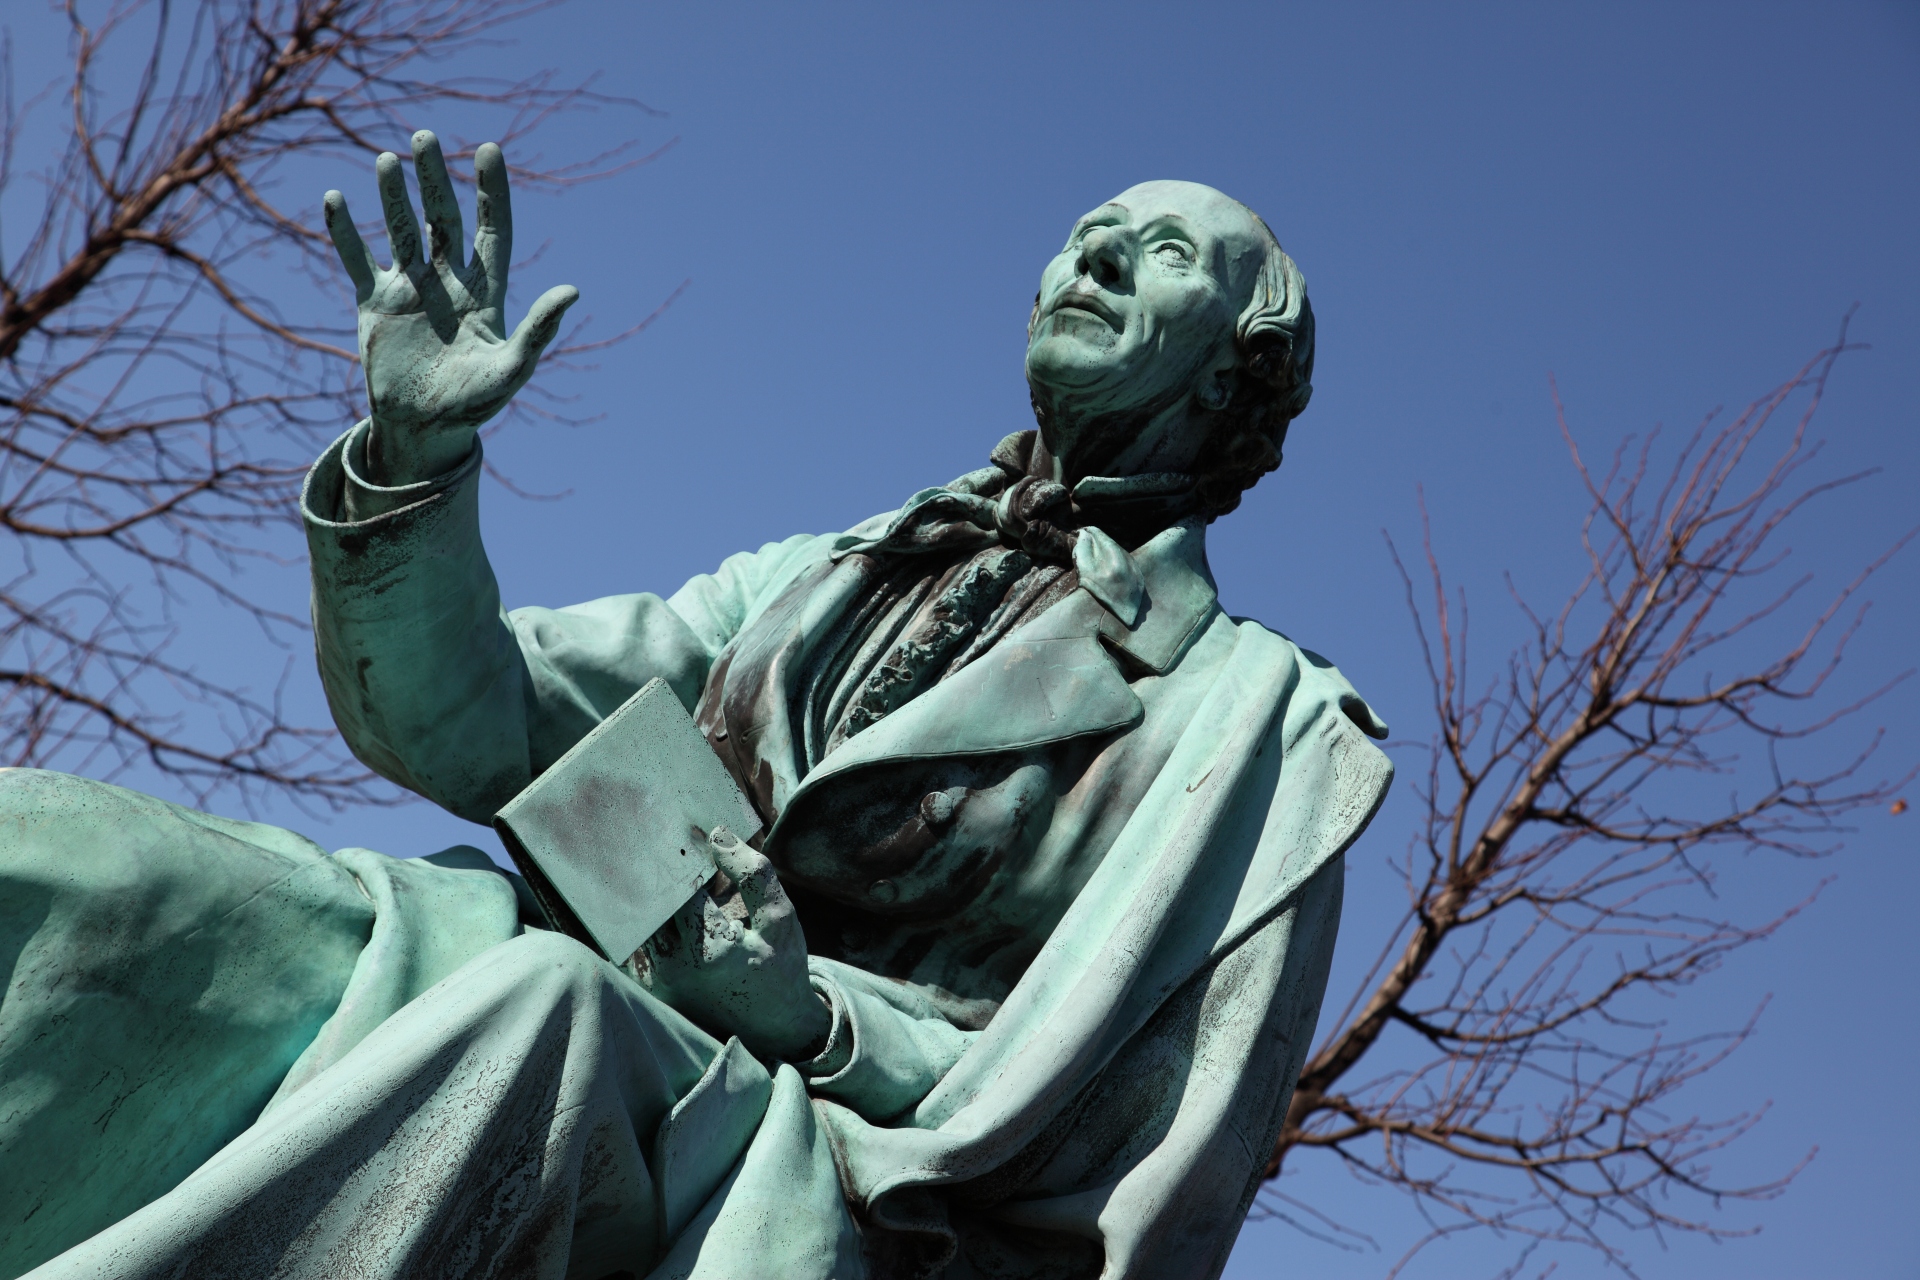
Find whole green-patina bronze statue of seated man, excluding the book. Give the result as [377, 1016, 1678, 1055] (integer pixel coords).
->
[0, 132, 1390, 1280]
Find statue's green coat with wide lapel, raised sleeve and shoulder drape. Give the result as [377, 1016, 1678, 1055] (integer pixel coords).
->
[307, 429, 1390, 1276]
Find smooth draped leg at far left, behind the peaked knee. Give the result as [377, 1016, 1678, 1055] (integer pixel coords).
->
[0, 770, 520, 1276]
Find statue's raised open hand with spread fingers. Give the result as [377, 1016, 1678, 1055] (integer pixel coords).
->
[326, 129, 580, 486]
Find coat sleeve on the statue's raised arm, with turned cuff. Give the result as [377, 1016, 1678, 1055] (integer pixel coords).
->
[301, 424, 828, 823]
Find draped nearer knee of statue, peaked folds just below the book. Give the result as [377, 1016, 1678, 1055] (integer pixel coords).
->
[20, 931, 862, 1280]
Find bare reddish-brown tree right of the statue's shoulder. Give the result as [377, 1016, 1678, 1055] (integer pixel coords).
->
[1267, 328, 1912, 1274]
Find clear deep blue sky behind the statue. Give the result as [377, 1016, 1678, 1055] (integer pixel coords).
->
[10, 0, 1920, 1280]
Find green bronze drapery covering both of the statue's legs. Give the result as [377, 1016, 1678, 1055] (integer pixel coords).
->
[0, 770, 860, 1280]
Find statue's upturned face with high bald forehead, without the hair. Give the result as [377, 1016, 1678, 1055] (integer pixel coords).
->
[1027, 173, 1267, 470]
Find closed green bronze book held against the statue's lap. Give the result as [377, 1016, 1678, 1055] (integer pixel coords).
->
[493, 679, 760, 963]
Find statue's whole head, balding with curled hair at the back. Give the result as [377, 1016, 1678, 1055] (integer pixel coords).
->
[1027, 182, 1313, 514]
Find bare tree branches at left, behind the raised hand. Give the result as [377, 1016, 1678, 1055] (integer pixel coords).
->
[0, 0, 672, 804]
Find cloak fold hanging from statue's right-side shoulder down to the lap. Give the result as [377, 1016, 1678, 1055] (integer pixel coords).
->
[822, 620, 1390, 1276]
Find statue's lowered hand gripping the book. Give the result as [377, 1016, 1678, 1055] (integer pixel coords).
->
[632, 829, 833, 1061]
